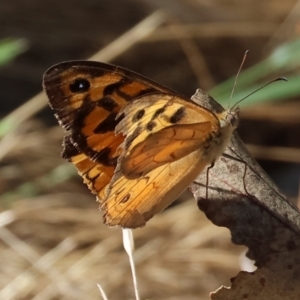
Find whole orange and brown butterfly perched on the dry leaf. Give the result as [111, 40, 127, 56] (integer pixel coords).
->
[43, 61, 238, 228]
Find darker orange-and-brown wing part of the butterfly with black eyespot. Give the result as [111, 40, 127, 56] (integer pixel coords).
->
[43, 61, 182, 204]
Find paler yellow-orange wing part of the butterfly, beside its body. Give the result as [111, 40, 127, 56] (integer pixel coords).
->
[102, 94, 219, 227]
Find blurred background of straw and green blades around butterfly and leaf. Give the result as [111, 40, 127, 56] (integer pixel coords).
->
[0, 0, 300, 300]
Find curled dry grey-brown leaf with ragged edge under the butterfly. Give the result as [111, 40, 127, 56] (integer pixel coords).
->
[190, 90, 300, 300]
